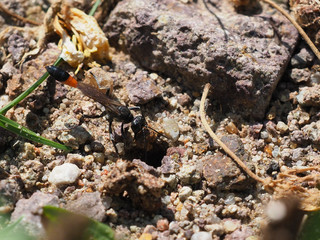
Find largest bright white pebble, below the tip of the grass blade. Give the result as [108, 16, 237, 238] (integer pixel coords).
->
[48, 163, 81, 185]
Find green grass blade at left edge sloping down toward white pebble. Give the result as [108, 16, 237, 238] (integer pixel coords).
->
[0, 114, 71, 151]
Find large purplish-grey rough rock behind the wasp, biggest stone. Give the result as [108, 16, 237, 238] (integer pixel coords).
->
[104, 0, 298, 118]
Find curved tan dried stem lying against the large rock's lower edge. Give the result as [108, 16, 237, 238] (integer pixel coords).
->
[200, 83, 267, 185]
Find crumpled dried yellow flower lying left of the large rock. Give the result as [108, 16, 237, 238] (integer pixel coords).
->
[53, 7, 111, 70]
